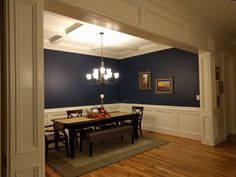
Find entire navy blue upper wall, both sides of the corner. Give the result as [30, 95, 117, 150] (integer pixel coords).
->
[44, 49, 199, 108]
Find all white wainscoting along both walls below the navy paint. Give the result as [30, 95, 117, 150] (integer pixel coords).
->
[45, 103, 201, 140]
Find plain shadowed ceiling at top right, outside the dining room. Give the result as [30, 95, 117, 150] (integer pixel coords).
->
[174, 0, 236, 44]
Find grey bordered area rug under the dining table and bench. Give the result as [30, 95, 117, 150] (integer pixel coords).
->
[46, 136, 168, 177]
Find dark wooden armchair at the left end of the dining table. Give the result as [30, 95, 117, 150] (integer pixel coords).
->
[44, 124, 69, 159]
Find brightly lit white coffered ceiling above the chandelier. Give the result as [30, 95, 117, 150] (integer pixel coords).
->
[44, 12, 171, 59]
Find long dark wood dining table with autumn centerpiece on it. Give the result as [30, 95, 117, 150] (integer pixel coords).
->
[53, 111, 139, 158]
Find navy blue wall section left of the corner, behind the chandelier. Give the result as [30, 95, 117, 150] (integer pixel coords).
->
[44, 49, 120, 108]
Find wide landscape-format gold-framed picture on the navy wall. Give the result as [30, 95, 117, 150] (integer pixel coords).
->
[156, 77, 173, 95]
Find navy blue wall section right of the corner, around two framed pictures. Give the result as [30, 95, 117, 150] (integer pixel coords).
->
[120, 49, 199, 107]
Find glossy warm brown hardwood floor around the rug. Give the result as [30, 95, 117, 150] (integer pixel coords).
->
[46, 131, 236, 177]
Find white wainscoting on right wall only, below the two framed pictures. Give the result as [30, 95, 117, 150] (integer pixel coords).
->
[120, 104, 201, 140]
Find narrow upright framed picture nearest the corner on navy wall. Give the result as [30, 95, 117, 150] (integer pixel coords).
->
[138, 71, 151, 90]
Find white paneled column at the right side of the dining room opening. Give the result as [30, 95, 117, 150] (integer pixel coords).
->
[199, 52, 216, 146]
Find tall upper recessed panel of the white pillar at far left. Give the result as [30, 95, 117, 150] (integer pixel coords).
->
[15, 1, 38, 154]
